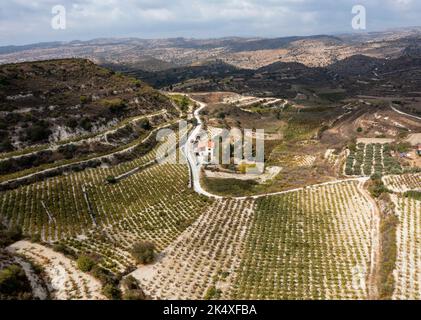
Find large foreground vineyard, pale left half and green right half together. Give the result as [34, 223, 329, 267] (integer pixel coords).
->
[132, 182, 375, 299]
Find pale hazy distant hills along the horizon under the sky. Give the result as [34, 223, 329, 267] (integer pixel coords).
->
[0, 28, 421, 71]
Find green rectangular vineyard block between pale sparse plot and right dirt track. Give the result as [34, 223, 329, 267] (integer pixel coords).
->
[233, 182, 374, 299]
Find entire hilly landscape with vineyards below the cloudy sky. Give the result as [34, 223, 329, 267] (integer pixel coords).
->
[0, 28, 421, 300]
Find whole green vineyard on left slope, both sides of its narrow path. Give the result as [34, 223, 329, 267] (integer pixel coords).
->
[0, 141, 208, 272]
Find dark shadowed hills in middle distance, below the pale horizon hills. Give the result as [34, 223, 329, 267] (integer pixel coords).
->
[128, 46, 421, 101]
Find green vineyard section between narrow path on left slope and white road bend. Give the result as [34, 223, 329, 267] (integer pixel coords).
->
[62, 164, 208, 272]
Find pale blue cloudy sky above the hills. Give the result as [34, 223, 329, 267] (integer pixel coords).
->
[0, 0, 421, 45]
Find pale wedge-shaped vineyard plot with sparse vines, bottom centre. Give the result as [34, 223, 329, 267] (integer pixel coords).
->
[132, 200, 253, 299]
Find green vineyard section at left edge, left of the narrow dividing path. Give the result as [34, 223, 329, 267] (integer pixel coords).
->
[0, 151, 156, 241]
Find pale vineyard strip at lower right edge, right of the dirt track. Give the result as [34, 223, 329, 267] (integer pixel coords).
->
[393, 196, 421, 300]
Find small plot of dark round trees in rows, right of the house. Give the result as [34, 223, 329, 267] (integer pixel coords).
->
[345, 143, 402, 176]
